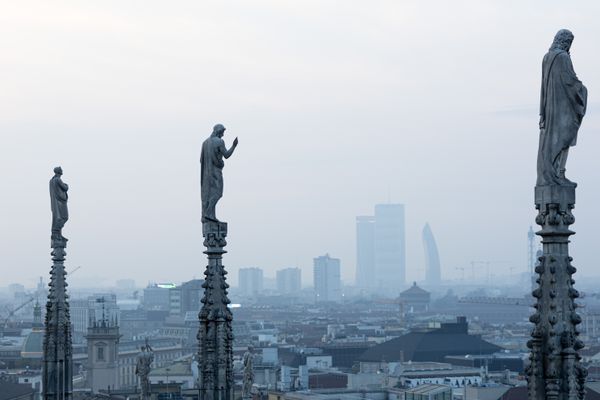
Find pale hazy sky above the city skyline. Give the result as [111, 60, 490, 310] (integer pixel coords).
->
[0, 0, 600, 289]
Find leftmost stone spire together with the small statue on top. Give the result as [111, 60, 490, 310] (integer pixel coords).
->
[42, 167, 73, 400]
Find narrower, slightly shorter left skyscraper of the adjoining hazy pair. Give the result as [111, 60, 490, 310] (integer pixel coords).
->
[356, 216, 377, 288]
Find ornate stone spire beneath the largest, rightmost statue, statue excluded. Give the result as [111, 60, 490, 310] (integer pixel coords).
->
[527, 185, 587, 400]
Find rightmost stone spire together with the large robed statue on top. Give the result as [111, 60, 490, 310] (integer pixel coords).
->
[526, 30, 587, 400]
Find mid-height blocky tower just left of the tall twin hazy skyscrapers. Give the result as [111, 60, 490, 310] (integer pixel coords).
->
[314, 254, 342, 303]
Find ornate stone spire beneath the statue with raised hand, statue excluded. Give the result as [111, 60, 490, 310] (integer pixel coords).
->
[198, 221, 234, 400]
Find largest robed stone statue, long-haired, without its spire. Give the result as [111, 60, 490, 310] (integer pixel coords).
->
[537, 29, 587, 186]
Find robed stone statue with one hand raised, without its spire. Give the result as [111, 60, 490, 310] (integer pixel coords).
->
[200, 124, 238, 222]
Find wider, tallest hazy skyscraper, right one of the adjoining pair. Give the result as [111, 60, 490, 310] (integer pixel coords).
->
[375, 204, 406, 290]
